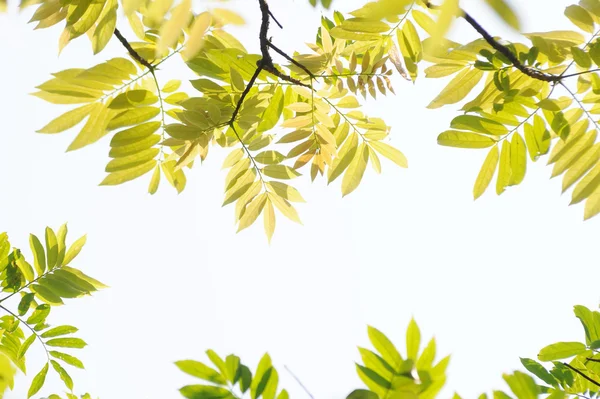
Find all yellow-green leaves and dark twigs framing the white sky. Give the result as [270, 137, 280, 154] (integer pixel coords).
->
[0, 0, 600, 399]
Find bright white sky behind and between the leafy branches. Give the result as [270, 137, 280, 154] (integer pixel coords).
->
[0, 0, 600, 399]
